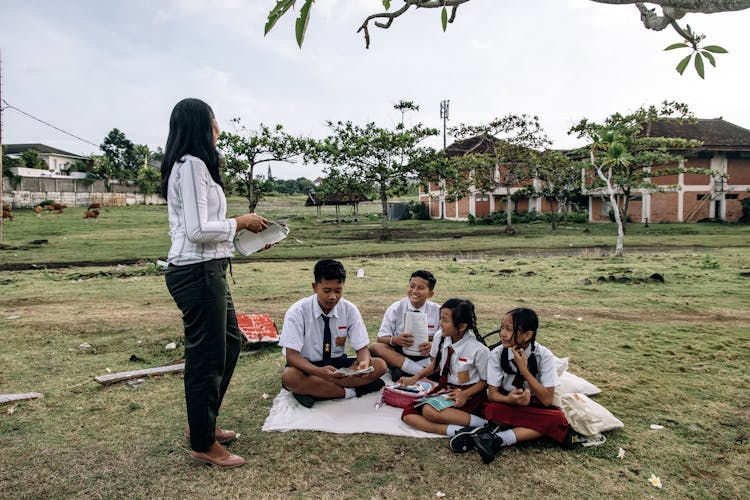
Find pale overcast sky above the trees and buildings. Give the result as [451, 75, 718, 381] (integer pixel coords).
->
[0, 0, 750, 179]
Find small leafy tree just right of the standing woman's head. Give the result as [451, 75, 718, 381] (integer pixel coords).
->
[218, 122, 305, 212]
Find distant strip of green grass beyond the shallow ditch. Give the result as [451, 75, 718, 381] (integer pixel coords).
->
[0, 196, 750, 266]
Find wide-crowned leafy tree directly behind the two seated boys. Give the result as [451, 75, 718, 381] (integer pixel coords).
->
[315, 122, 437, 239]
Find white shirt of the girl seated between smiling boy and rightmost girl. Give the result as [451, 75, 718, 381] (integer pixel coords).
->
[430, 331, 490, 385]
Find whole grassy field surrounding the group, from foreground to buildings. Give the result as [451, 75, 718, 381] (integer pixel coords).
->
[0, 197, 750, 498]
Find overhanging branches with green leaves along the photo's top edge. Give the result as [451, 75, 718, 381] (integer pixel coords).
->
[264, 0, 750, 78]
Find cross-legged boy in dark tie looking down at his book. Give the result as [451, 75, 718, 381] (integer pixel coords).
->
[279, 259, 387, 408]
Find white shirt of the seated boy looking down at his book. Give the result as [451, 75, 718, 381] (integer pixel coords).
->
[279, 295, 370, 362]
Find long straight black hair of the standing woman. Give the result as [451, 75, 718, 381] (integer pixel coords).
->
[161, 98, 224, 198]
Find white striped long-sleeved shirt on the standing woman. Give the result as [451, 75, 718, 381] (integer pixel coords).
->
[167, 155, 237, 266]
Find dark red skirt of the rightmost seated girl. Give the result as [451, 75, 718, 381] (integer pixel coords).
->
[484, 401, 568, 444]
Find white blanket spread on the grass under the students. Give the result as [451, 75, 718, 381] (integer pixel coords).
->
[263, 374, 445, 438]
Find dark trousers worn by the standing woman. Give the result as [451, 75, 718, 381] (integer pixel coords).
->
[166, 259, 241, 452]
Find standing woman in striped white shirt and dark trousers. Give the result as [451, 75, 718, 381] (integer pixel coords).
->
[161, 99, 268, 467]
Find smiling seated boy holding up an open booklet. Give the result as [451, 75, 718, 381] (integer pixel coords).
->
[370, 270, 440, 382]
